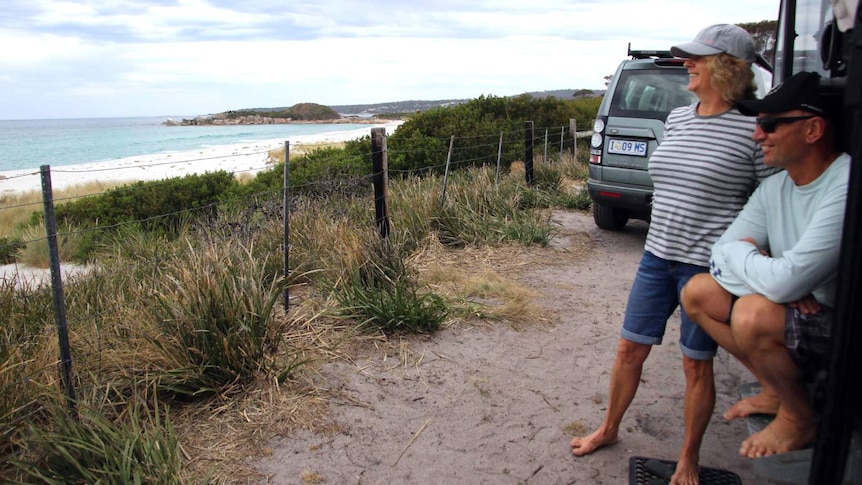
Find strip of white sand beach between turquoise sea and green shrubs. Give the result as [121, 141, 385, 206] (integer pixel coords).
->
[0, 120, 403, 195]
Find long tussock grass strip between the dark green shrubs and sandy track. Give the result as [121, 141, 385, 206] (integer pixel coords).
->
[0, 158, 592, 483]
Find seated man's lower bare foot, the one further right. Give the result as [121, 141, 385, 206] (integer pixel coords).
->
[739, 413, 817, 458]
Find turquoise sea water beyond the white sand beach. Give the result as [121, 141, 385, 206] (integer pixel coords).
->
[0, 116, 378, 171]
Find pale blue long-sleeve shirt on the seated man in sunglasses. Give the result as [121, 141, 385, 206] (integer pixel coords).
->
[710, 154, 850, 306]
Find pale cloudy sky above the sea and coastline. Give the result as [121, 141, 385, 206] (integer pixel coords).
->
[0, 0, 779, 120]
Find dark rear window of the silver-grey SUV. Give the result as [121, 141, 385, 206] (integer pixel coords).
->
[608, 69, 697, 121]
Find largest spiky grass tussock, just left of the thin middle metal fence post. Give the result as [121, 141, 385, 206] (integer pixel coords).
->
[143, 240, 290, 397]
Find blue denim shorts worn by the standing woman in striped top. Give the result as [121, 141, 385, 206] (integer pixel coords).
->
[622, 251, 718, 360]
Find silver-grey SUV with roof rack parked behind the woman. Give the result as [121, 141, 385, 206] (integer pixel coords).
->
[587, 44, 772, 231]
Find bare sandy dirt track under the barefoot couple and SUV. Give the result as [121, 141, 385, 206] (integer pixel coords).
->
[253, 212, 788, 484]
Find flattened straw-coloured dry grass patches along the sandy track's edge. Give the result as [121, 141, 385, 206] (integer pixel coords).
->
[152, 233, 576, 483]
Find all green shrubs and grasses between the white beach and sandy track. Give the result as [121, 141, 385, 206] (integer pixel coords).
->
[0, 90, 598, 483]
